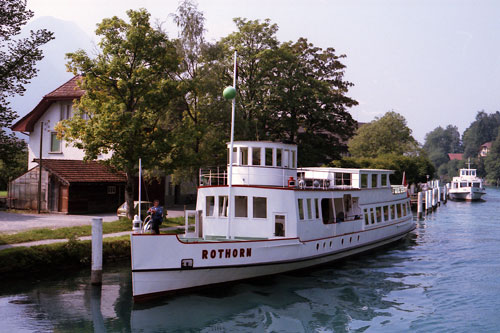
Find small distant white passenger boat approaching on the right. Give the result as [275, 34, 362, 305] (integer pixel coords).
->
[448, 162, 486, 201]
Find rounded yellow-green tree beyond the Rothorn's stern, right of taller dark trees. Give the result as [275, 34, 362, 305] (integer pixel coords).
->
[348, 111, 418, 157]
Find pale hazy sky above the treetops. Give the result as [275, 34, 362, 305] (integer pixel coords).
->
[28, 0, 500, 143]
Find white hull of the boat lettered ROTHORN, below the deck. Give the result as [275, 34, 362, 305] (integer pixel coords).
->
[131, 217, 415, 300]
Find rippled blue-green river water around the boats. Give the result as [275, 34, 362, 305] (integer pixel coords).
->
[0, 188, 500, 333]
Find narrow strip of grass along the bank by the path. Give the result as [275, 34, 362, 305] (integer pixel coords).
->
[0, 217, 184, 245]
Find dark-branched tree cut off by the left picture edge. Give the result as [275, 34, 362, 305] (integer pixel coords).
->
[0, 0, 54, 188]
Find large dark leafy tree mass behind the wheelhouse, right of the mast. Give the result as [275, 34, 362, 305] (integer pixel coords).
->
[219, 18, 357, 165]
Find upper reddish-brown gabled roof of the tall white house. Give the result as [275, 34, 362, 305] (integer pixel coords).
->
[11, 75, 85, 132]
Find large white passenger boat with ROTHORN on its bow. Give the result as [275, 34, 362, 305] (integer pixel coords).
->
[131, 141, 415, 300]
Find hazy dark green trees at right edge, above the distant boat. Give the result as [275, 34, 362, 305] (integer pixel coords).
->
[462, 111, 500, 158]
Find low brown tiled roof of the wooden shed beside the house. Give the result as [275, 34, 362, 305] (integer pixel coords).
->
[34, 159, 127, 185]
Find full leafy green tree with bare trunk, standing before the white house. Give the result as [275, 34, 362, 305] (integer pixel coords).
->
[57, 9, 178, 218]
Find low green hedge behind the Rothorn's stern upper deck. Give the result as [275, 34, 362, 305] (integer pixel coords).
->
[332, 154, 435, 184]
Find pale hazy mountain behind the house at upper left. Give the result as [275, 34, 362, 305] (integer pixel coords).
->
[9, 16, 94, 122]
